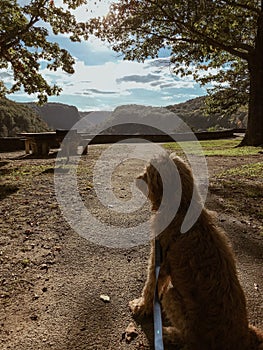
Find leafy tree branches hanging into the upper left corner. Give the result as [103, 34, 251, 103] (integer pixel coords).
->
[0, 0, 87, 103]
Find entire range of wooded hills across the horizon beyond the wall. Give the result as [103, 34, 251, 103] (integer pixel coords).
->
[0, 97, 247, 137]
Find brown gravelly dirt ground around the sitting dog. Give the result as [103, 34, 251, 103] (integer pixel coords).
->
[0, 146, 263, 350]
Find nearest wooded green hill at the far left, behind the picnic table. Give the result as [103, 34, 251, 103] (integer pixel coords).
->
[0, 98, 49, 137]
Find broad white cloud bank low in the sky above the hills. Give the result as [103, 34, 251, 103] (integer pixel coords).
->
[6, 54, 205, 110]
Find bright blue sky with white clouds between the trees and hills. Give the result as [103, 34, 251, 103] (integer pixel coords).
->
[6, 0, 206, 111]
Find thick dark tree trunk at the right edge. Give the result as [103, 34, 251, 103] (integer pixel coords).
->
[240, 13, 263, 146]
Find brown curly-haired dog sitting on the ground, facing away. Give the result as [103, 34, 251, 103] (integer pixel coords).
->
[129, 156, 263, 350]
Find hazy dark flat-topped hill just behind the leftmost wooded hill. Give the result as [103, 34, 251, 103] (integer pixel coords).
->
[27, 102, 80, 130]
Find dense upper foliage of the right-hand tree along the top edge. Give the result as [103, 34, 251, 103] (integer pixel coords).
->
[90, 0, 261, 60]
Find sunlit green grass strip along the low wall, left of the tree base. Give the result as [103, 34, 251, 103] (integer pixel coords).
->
[164, 138, 262, 157]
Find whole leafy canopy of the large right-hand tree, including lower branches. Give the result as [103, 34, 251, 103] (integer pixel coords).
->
[89, 0, 263, 144]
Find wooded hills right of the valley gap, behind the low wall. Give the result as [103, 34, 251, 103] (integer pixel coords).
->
[87, 96, 247, 134]
